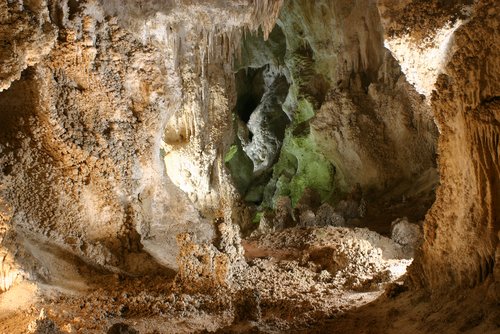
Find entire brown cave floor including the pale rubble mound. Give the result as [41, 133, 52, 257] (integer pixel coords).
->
[0, 222, 500, 334]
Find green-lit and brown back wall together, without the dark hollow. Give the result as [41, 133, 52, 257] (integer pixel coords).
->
[229, 1, 437, 217]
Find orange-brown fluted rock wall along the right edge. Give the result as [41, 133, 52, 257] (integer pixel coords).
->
[398, 1, 500, 292]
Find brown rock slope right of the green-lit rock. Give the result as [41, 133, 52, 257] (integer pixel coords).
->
[290, 2, 435, 194]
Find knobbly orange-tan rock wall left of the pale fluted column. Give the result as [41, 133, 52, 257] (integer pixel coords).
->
[0, 0, 207, 280]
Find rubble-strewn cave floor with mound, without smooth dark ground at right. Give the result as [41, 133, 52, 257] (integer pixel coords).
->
[0, 226, 412, 333]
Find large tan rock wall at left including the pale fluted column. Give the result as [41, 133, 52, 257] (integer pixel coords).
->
[0, 1, 279, 285]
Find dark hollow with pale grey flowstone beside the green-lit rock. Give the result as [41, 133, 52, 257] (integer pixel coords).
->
[226, 64, 290, 205]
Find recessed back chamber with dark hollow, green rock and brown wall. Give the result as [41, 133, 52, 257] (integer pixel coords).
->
[225, 16, 438, 236]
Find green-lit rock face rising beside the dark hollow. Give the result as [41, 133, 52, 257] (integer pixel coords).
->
[226, 0, 341, 214]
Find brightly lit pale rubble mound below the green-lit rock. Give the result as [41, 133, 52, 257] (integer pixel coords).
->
[245, 227, 412, 290]
